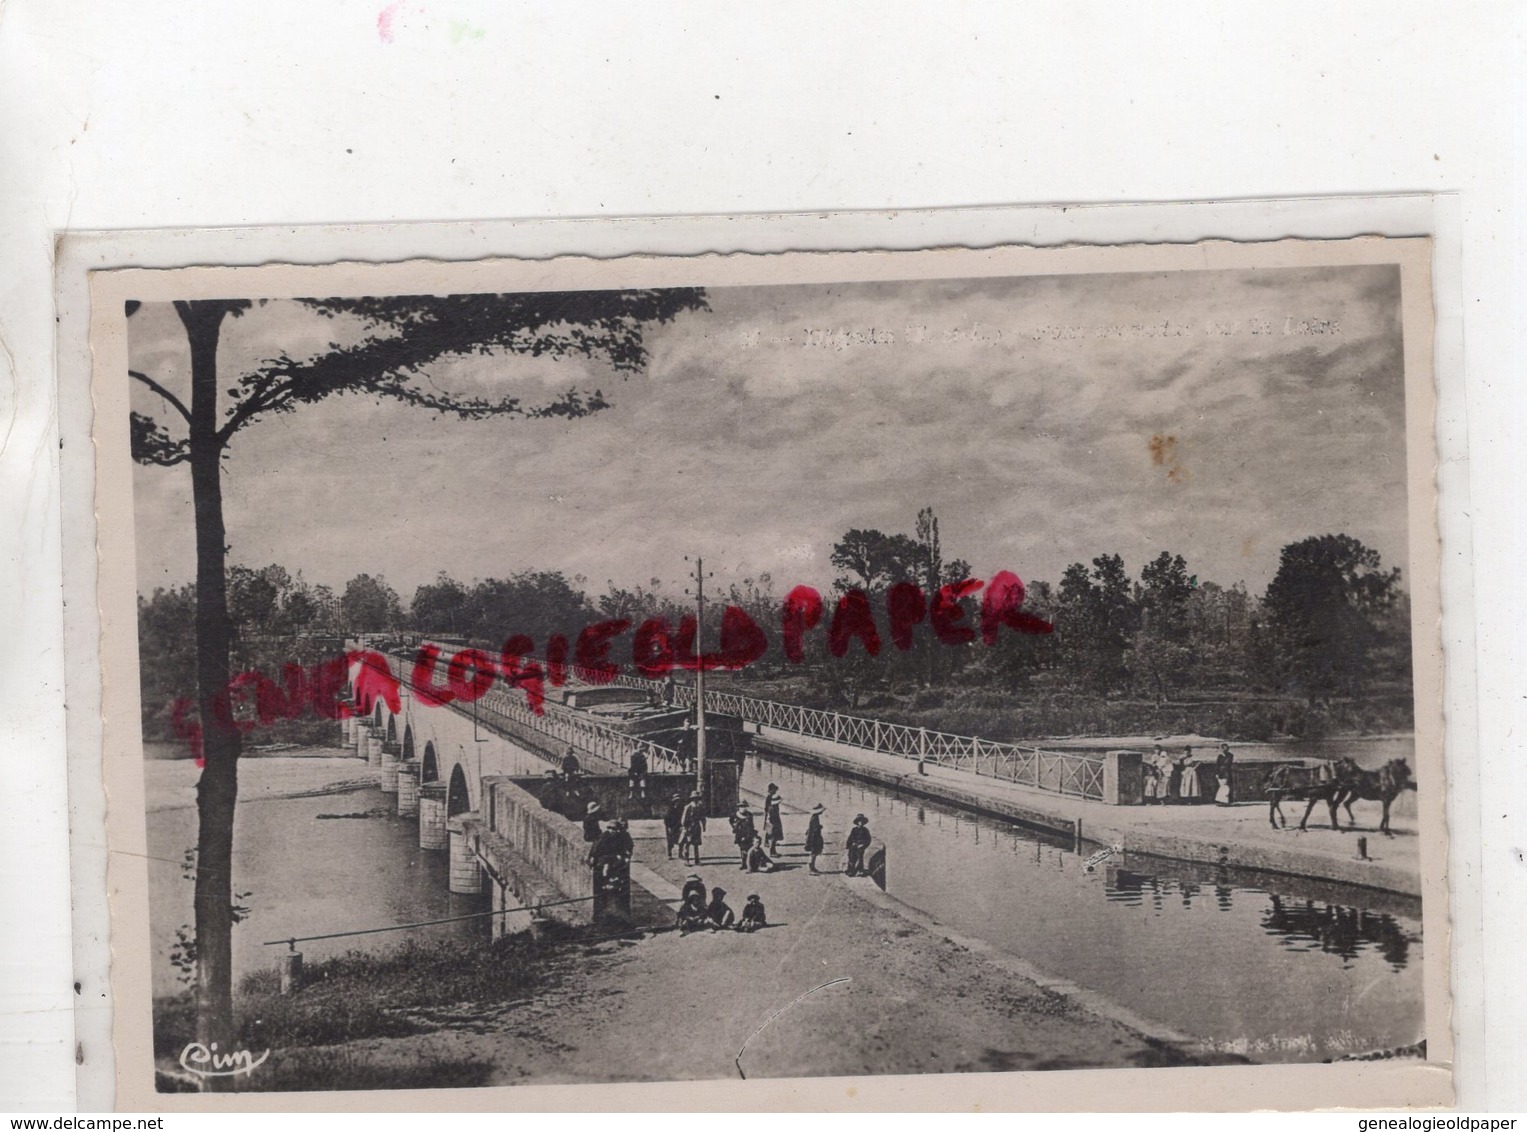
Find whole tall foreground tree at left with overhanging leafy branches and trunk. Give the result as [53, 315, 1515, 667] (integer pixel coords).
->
[127, 289, 705, 1057]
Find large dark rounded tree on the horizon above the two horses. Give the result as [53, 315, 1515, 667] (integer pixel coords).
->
[1263, 535, 1400, 706]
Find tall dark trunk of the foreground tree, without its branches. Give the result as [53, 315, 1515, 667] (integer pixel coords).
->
[176, 302, 241, 1063]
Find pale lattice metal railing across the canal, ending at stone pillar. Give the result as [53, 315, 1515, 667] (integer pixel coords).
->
[601, 674, 1102, 800]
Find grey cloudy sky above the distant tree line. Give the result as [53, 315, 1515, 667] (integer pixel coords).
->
[130, 267, 1406, 600]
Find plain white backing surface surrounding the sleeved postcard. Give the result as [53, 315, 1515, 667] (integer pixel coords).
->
[0, 0, 1527, 1111]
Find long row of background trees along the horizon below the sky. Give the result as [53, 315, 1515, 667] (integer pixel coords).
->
[140, 525, 1409, 738]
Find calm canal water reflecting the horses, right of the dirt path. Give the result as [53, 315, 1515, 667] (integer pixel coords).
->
[744, 744, 1423, 1062]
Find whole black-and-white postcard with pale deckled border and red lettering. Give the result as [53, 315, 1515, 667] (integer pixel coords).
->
[93, 240, 1451, 1105]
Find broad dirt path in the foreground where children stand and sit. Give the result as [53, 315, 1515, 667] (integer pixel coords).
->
[337, 814, 1238, 1085]
